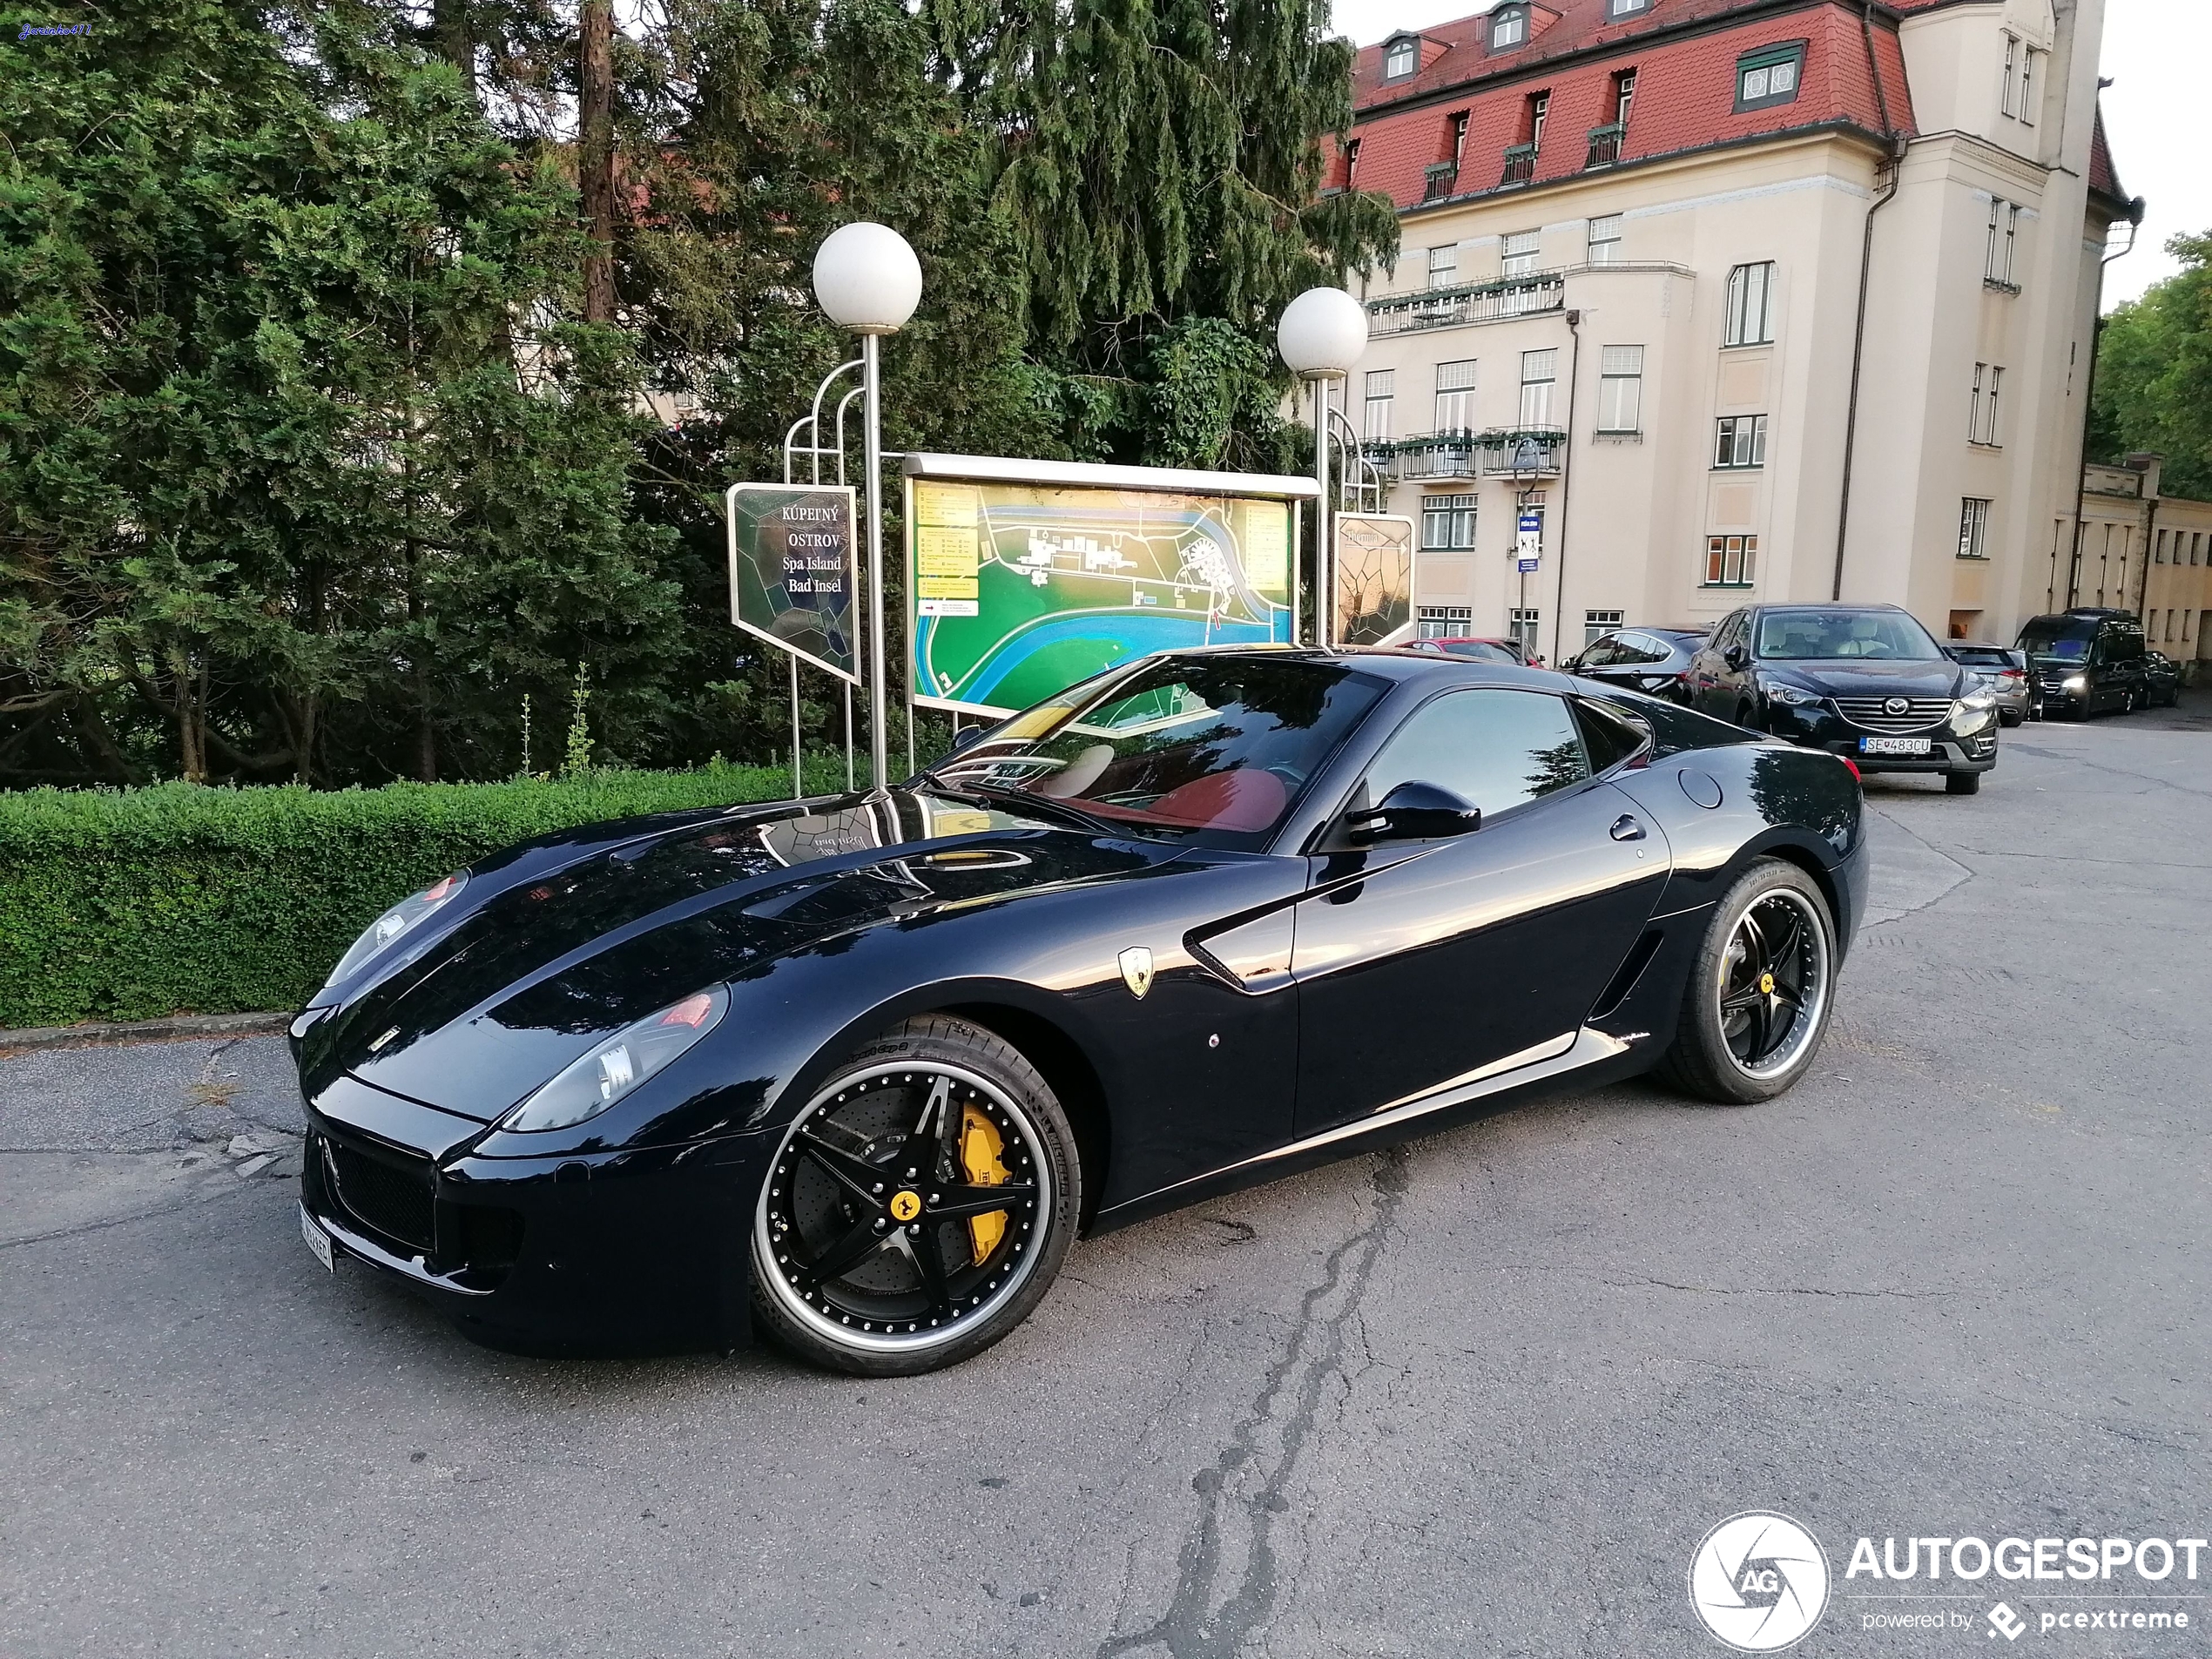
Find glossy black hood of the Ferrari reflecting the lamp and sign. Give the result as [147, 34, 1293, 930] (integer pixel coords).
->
[300, 790, 1181, 1123]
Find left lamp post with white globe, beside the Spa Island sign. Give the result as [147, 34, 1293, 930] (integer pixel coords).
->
[814, 219, 922, 790]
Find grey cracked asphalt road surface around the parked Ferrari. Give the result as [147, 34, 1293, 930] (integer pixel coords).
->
[0, 701, 2212, 1659]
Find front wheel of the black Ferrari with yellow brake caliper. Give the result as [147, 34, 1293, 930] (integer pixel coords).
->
[752, 1015, 1082, 1376]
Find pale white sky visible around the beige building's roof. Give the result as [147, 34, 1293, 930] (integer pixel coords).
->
[1332, 0, 2212, 307]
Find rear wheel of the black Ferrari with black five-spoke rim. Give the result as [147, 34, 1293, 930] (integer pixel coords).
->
[1666, 859, 1836, 1106]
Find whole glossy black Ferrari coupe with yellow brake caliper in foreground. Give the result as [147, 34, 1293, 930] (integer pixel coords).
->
[292, 648, 1867, 1376]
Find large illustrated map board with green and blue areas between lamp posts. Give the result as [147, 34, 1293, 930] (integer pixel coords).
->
[905, 455, 1314, 714]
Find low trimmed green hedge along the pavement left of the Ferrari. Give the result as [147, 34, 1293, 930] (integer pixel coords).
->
[0, 754, 845, 1028]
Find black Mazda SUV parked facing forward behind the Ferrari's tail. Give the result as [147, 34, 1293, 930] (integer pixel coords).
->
[1690, 604, 1998, 794]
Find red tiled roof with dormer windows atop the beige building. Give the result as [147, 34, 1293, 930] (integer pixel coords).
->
[1332, 0, 1913, 208]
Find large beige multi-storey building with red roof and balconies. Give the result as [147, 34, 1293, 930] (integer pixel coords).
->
[1334, 0, 2149, 661]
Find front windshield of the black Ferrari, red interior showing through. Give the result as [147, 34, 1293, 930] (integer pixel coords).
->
[935, 657, 1385, 847]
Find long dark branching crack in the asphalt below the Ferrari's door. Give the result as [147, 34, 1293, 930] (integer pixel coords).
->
[1097, 1146, 1406, 1659]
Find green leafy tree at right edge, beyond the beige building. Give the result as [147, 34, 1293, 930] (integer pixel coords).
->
[2090, 233, 2212, 500]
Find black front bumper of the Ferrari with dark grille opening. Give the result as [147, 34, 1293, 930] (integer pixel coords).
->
[300, 1077, 774, 1353]
